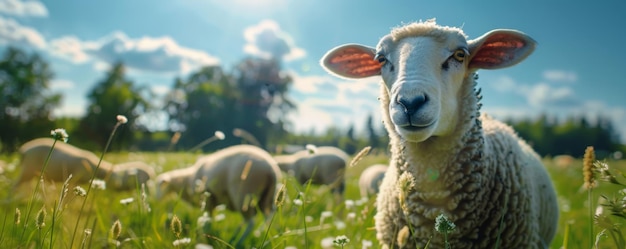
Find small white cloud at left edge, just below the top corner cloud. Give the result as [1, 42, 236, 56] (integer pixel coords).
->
[0, 16, 46, 49]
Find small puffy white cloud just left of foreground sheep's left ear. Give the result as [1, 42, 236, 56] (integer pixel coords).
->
[243, 20, 306, 61]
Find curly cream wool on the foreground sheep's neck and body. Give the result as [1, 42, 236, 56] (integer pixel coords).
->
[375, 77, 558, 248]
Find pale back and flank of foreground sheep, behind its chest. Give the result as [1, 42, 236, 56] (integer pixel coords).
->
[481, 115, 559, 247]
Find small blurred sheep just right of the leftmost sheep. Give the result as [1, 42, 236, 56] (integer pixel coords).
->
[109, 161, 156, 190]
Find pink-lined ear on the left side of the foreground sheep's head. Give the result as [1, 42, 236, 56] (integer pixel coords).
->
[321, 44, 381, 79]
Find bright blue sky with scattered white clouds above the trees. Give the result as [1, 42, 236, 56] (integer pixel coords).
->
[0, 0, 626, 142]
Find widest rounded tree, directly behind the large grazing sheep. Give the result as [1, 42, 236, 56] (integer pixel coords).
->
[165, 58, 294, 150]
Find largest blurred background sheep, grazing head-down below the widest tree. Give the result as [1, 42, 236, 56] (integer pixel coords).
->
[157, 145, 281, 242]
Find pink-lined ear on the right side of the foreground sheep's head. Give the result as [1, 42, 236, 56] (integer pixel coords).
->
[468, 29, 537, 69]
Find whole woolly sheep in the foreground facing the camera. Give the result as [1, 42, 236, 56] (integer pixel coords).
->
[321, 20, 559, 248]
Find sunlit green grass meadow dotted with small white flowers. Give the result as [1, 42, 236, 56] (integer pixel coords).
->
[0, 149, 626, 248]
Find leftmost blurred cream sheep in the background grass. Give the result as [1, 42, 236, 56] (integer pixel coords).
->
[15, 138, 112, 187]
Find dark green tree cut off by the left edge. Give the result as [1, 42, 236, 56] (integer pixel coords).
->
[0, 47, 61, 151]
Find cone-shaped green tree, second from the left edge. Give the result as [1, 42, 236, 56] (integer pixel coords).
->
[79, 62, 150, 150]
